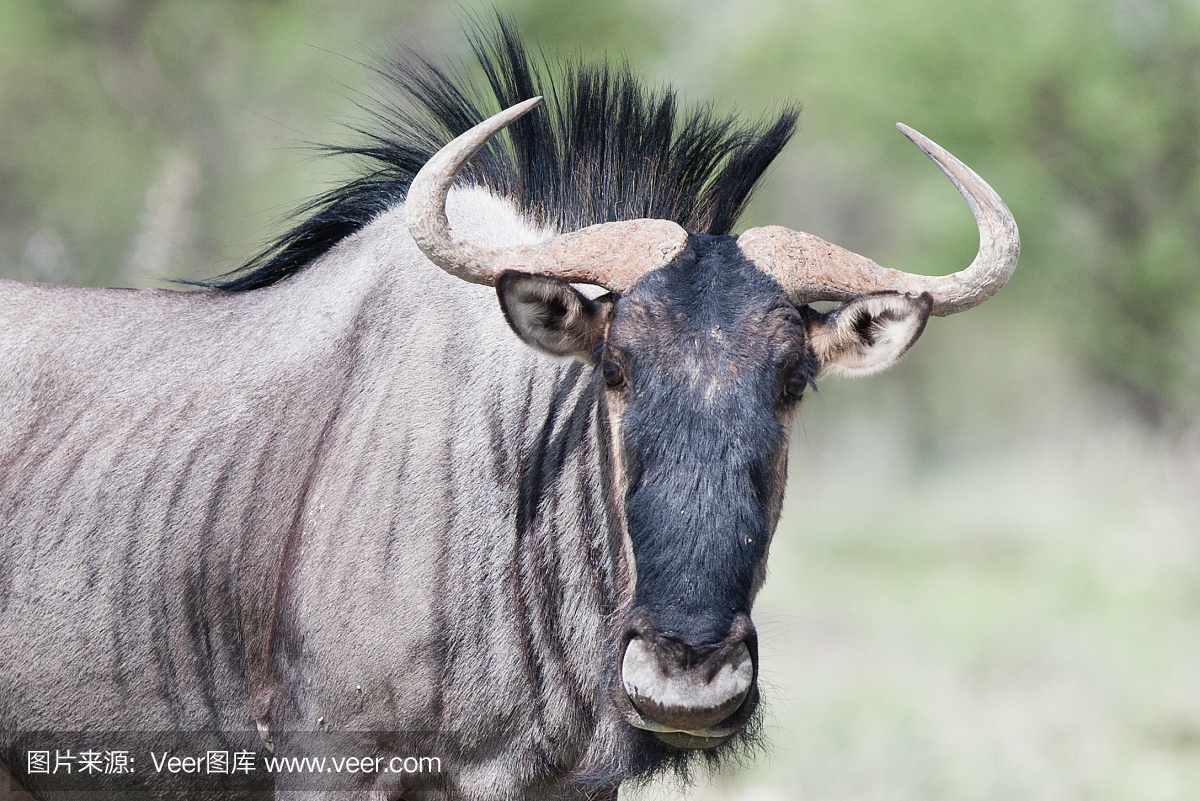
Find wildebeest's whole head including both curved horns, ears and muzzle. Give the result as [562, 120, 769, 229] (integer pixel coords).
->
[407, 98, 1019, 748]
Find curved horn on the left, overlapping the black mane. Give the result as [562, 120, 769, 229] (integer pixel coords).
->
[404, 97, 688, 293]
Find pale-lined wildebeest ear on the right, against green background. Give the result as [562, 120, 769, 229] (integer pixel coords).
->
[805, 293, 934, 375]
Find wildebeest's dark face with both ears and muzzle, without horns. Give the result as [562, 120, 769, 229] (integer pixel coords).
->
[497, 236, 930, 748]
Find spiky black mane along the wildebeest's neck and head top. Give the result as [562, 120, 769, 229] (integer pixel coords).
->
[211, 19, 799, 291]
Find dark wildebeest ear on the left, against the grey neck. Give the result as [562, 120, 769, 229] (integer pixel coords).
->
[496, 270, 612, 365]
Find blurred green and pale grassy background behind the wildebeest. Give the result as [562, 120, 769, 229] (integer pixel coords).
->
[0, 0, 1200, 801]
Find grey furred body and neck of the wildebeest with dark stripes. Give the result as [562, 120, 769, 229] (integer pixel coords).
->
[0, 191, 630, 799]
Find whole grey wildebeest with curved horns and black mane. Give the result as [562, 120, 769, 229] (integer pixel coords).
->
[0, 20, 1019, 800]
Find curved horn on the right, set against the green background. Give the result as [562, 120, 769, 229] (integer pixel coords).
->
[738, 124, 1021, 317]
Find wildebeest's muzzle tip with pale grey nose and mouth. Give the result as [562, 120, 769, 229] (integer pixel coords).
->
[620, 637, 755, 731]
